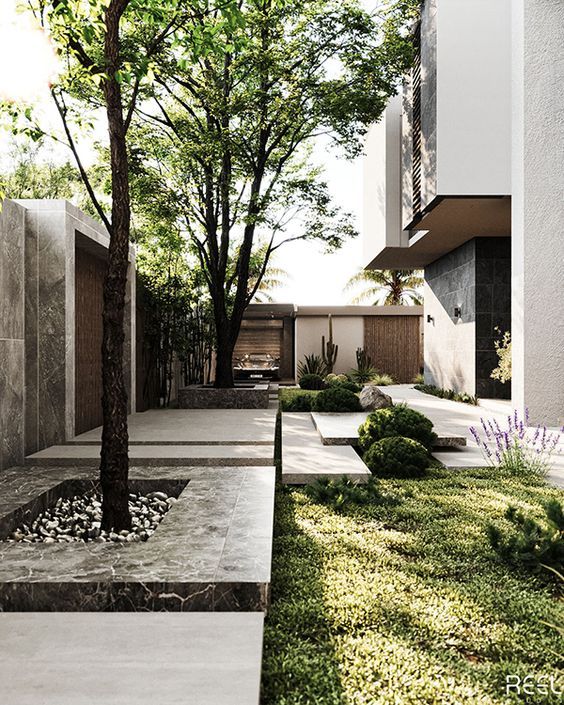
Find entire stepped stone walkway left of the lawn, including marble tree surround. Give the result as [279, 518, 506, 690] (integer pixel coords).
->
[4, 404, 278, 705]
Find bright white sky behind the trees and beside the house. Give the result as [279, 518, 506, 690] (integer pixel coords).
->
[0, 0, 372, 305]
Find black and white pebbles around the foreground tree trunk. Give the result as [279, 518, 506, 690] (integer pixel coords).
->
[7, 491, 176, 543]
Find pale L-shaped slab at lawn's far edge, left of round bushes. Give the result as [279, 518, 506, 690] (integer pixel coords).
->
[282, 413, 371, 485]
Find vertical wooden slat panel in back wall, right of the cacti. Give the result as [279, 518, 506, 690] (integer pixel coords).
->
[364, 316, 421, 384]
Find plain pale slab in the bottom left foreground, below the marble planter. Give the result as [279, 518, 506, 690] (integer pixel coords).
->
[0, 612, 264, 705]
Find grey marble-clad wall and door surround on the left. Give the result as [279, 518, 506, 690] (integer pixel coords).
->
[0, 200, 135, 469]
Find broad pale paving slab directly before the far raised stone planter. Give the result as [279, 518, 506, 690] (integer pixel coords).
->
[70, 409, 276, 445]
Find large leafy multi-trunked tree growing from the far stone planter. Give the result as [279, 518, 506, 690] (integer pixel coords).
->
[129, 0, 418, 387]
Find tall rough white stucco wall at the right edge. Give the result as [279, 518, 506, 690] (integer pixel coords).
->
[512, 0, 564, 425]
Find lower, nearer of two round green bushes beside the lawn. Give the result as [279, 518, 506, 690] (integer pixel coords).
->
[363, 436, 429, 477]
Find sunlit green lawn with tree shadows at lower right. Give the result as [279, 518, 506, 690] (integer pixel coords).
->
[262, 469, 563, 705]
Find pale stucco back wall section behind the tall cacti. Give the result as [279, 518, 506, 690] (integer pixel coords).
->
[295, 316, 364, 375]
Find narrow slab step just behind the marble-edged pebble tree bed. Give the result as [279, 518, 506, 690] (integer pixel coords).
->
[25, 444, 274, 466]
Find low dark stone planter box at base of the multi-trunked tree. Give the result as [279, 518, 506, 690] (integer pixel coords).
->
[178, 383, 270, 409]
